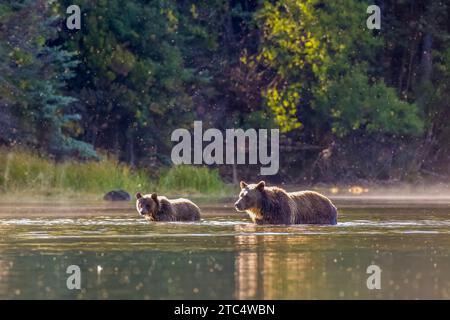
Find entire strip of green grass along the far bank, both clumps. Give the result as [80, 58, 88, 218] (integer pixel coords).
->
[0, 148, 231, 200]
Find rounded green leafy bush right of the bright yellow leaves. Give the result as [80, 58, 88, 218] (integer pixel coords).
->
[316, 66, 423, 137]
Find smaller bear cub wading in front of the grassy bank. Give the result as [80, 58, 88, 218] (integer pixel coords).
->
[136, 192, 200, 221]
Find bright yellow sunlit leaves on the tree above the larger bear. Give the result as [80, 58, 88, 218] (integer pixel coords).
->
[251, 0, 326, 132]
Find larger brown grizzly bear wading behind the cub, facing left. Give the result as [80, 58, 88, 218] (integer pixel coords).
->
[234, 181, 337, 224]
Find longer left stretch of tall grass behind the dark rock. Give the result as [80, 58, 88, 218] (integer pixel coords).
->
[0, 149, 152, 196]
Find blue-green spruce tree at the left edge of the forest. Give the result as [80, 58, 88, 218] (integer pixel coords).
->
[0, 0, 97, 158]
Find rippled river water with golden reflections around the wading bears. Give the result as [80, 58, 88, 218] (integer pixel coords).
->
[0, 201, 450, 299]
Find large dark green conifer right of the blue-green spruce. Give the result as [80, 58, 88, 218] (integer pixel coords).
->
[60, 0, 206, 161]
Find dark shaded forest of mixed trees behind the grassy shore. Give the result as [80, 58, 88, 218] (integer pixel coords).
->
[0, 0, 450, 183]
